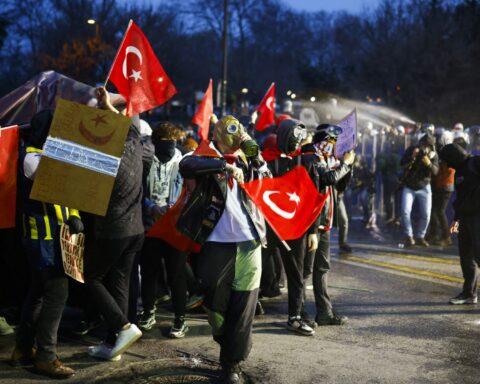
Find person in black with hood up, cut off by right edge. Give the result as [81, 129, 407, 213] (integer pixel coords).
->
[440, 143, 480, 305]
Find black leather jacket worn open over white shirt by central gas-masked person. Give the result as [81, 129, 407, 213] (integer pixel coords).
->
[177, 150, 271, 246]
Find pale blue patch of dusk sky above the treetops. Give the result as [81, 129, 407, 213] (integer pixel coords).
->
[282, 0, 380, 13]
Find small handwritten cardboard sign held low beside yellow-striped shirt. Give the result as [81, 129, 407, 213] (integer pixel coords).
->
[60, 223, 85, 283]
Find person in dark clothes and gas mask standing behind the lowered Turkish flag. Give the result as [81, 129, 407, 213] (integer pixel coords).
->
[268, 119, 318, 336]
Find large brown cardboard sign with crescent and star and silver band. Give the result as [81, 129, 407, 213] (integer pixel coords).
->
[30, 99, 131, 216]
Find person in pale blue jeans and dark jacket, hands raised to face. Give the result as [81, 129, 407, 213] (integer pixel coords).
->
[400, 132, 439, 247]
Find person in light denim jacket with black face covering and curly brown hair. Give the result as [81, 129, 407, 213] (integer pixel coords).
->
[139, 122, 188, 338]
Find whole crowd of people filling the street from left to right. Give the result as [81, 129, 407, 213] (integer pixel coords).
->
[0, 88, 480, 383]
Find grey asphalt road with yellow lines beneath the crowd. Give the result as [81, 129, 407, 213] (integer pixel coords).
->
[0, 224, 480, 384]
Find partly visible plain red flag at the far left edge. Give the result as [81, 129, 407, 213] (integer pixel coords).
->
[0, 126, 19, 228]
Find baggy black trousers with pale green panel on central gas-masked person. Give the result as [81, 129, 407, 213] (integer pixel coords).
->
[197, 240, 262, 367]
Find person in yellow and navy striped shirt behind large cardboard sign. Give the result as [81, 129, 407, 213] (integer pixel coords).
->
[11, 110, 83, 379]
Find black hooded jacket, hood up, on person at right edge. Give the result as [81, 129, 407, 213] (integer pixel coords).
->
[440, 144, 480, 220]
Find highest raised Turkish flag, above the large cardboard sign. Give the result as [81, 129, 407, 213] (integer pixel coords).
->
[107, 20, 177, 116]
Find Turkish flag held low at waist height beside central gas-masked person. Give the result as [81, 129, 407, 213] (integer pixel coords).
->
[242, 166, 327, 240]
